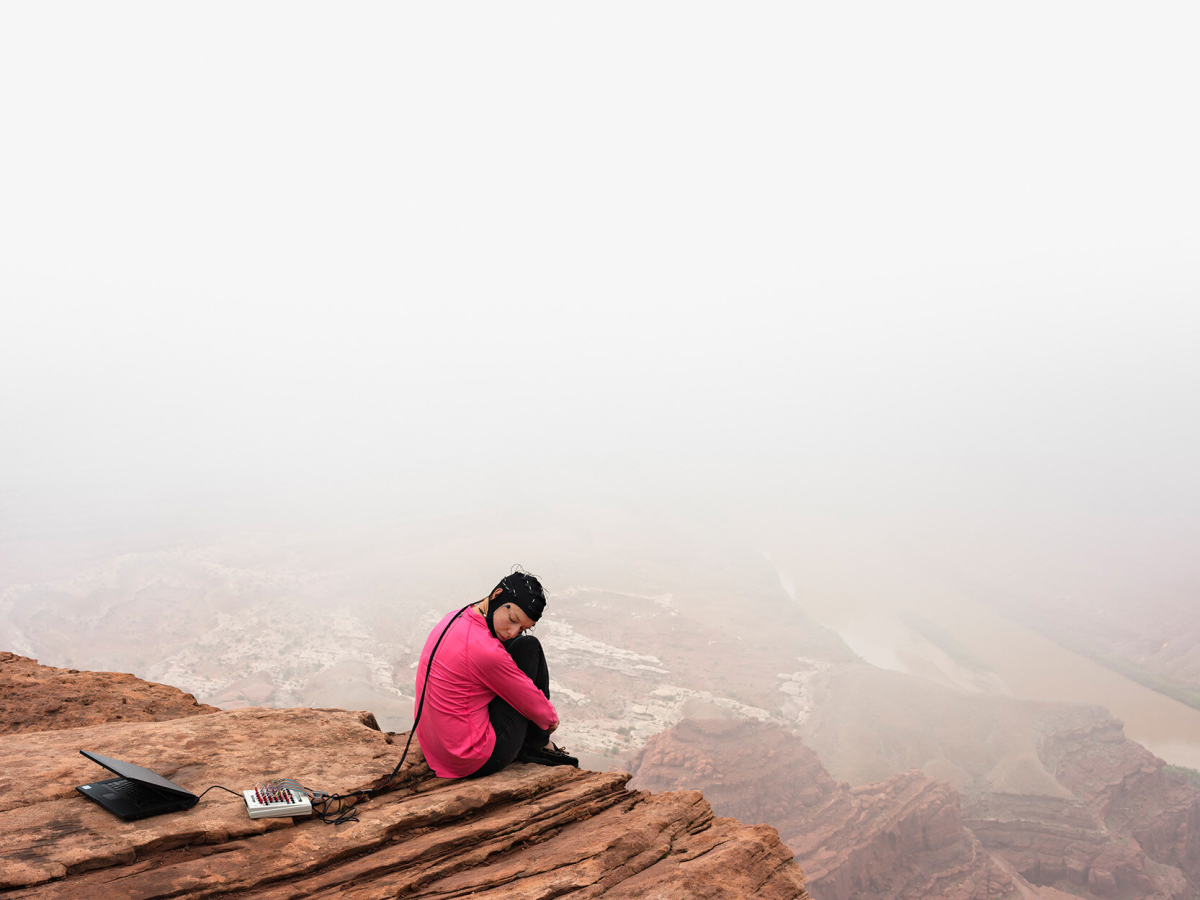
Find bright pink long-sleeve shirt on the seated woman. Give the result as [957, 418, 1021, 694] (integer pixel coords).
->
[413, 607, 558, 778]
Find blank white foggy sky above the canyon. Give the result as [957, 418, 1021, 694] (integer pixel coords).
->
[0, 2, 1200, 607]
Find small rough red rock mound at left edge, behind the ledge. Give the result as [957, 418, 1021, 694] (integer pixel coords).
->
[0, 652, 217, 734]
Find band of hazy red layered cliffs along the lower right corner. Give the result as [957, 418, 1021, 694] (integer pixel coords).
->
[632, 704, 1200, 900]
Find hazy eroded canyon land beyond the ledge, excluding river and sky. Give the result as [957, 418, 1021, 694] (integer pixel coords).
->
[0, 523, 1200, 900]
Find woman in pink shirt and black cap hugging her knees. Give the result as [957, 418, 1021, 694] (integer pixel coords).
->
[416, 571, 578, 778]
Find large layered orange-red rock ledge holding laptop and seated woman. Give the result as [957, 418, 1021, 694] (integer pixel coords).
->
[0, 657, 808, 900]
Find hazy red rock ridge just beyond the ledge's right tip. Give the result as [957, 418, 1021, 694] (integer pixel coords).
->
[635, 720, 1015, 900]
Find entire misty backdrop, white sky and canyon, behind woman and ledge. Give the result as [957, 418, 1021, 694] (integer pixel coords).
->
[0, 2, 1200, 900]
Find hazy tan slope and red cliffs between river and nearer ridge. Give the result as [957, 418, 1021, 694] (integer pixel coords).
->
[796, 666, 1200, 900]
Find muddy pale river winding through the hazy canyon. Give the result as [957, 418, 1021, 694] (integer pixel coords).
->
[766, 545, 1200, 769]
